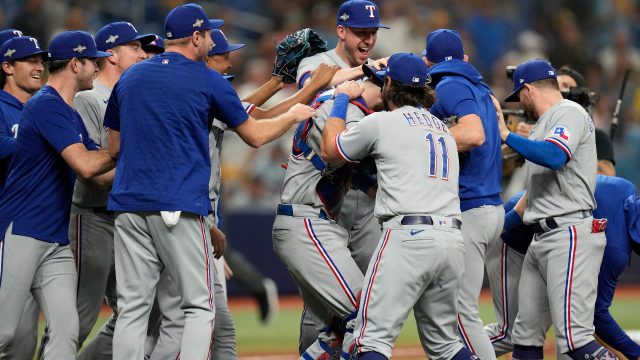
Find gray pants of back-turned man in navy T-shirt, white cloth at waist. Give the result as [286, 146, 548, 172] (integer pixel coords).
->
[113, 212, 215, 360]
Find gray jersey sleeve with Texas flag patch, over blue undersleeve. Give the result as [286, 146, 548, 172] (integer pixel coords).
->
[544, 106, 592, 160]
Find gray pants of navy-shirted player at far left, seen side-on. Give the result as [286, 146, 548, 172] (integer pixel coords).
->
[0, 226, 78, 360]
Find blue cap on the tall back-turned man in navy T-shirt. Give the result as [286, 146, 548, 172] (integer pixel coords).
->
[164, 4, 224, 40]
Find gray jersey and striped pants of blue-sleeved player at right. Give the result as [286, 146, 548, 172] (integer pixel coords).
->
[511, 100, 605, 353]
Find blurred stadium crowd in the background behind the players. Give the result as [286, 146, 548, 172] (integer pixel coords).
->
[5, 0, 640, 213]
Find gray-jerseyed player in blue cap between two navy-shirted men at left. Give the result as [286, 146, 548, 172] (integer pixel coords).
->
[64, 21, 154, 359]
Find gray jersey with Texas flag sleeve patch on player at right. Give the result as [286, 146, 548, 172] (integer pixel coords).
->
[523, 100, 597, 224]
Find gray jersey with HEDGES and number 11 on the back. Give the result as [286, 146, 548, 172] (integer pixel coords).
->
[337, 107, 460, 221]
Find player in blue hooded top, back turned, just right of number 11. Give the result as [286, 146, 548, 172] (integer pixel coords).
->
[424, 29, 504, 360]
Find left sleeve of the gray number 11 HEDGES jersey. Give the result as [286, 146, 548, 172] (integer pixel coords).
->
[336, 116, 379, 162]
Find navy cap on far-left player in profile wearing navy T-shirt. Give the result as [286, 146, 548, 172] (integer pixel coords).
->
[49, 30, 111, 60]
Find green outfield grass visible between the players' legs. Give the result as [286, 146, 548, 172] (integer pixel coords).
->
[40, 298, 640, 359]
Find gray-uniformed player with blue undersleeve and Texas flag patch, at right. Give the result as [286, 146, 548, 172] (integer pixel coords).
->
[499, 60, 615, 359]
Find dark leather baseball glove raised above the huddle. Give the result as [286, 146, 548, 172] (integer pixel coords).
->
[273, 28, 327, 84]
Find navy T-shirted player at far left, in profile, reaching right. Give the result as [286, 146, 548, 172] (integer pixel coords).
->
[0, 31, 114, 359]
